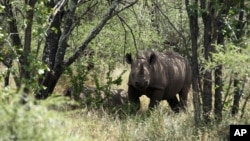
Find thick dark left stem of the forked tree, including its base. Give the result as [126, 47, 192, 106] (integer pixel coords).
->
[36, 0, 67, 99]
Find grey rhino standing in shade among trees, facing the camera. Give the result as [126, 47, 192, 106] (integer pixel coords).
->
[126, 51, 192, 112]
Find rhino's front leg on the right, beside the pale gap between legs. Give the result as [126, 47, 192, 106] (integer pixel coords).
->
[147, 90, 164, 107]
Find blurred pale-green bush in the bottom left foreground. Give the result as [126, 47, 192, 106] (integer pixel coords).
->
[0, 89, 80, 141]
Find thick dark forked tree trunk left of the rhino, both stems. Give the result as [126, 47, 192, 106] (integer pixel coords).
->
[36, 0, 77, 99]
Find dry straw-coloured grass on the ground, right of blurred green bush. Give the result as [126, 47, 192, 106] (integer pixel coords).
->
[0, 63, 250, 141]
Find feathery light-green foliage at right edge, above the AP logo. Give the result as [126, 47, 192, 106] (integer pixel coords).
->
[204, 43, 250, 111]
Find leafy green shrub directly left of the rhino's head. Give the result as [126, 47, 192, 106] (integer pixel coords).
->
[63, 57, 126, 107]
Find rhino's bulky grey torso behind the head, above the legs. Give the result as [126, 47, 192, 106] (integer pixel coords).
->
[149, 52, 190, 97]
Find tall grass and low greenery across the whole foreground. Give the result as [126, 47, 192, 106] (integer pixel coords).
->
[0, 66, 250, 141]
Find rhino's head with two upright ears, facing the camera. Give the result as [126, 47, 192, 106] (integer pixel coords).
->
[126, 52, 156, 90]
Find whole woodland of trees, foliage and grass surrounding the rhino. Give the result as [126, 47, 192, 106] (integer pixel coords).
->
[0, 0, 250, 140]
